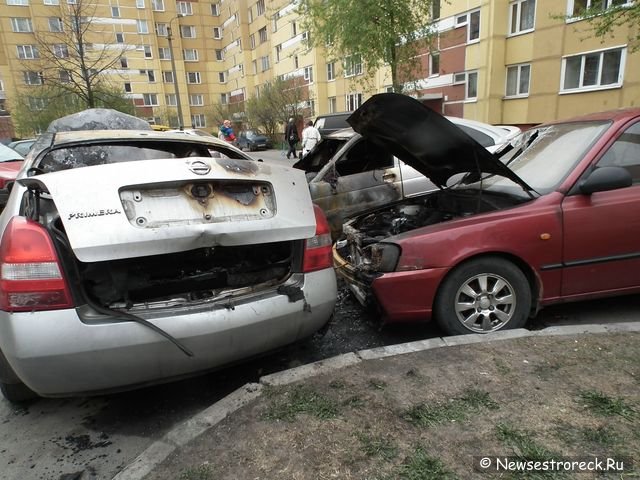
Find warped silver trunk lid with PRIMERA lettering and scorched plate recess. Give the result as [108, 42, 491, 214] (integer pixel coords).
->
[19, 157, 315, 262]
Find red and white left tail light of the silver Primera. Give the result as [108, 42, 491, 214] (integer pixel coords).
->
[0, 217, 73, 312]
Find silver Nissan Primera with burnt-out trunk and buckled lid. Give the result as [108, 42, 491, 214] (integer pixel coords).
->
[0, 114, 336, 401]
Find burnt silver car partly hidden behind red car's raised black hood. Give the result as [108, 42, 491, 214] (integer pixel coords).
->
[293, 117, 520, 238]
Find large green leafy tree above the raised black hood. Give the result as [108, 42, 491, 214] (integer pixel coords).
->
[299, 0, 440, 92]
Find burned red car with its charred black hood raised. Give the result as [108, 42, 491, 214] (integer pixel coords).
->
[334, 94, 640, 334]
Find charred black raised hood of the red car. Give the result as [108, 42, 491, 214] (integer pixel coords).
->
[347, 93, 532, 191]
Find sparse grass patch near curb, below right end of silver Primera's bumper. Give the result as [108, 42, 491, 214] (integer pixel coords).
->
[262, 386, 339, 422]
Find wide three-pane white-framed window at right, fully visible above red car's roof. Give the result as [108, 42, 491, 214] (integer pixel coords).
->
[560, 48, 626, 93]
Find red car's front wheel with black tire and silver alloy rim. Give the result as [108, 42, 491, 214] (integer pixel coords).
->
[434, 257, 531, 335]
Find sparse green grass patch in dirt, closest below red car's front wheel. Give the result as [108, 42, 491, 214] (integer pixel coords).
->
[402, 389, 498, 427]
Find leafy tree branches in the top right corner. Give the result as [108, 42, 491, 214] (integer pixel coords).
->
[574, 0, 640, 51]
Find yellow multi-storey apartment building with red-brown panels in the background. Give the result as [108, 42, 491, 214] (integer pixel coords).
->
[0, 0, 640, 139]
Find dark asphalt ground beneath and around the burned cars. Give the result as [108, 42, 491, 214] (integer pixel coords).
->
[0, 150, 640, 480]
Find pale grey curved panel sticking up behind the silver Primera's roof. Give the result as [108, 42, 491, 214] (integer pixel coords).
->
[47, 108, 151, 133]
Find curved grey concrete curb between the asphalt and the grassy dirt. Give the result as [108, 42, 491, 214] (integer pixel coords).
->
[112, 322, 640, 480]
